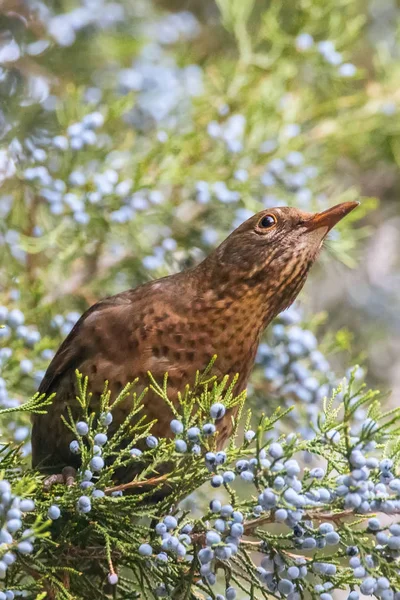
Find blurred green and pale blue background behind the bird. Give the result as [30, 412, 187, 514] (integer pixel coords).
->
[0, 0, 400, 454]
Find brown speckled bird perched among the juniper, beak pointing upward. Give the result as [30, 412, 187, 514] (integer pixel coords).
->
[32, 202, 358, 480]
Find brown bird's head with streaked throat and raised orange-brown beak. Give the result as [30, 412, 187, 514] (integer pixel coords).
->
[211, 202, 359, 313]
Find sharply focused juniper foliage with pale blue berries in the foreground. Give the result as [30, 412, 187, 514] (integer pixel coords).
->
[0, 370, 400, 599]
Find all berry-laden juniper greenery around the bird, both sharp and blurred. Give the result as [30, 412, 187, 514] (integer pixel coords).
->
[0, 0, 400, 600]
